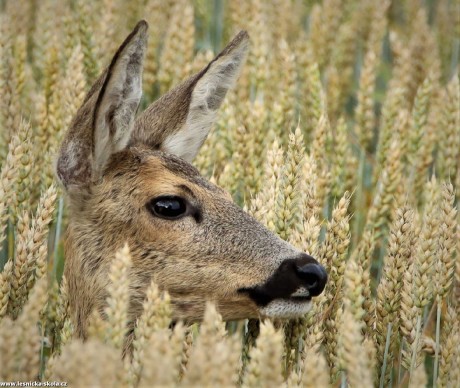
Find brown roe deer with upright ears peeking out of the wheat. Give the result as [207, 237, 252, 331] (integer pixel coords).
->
[57, 21, 327, 337]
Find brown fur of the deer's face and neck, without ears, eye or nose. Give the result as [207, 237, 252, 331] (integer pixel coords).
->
[65, 148, 289, 334]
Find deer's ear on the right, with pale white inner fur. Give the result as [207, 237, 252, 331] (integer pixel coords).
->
[130, 31, 249, 162]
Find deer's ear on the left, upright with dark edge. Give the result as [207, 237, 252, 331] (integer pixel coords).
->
[57, 21, 148, 188]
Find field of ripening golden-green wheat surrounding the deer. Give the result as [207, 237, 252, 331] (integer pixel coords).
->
[0, 0, 460, 388]
